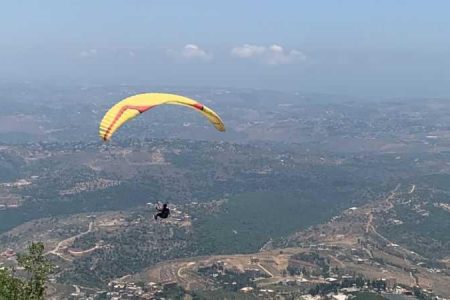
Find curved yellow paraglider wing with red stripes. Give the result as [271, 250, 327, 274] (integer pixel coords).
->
[99, 93, 225, 141]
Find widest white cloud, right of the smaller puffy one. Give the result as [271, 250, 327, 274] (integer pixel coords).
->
[231, 44, 306, 65]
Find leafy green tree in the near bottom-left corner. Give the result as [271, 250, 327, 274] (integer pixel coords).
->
[0, 243, 53, 300]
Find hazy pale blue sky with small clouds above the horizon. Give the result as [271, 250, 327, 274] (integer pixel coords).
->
[0, 0, 450, 97]
